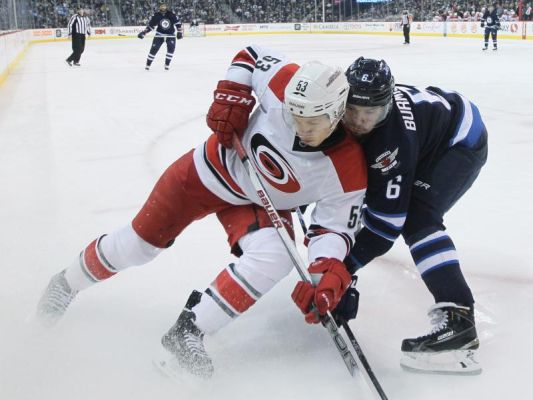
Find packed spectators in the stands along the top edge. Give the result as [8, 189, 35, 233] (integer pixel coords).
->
[10, 0, 533, 28]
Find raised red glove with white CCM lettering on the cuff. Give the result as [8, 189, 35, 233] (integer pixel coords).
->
[206, 81, 255, 149]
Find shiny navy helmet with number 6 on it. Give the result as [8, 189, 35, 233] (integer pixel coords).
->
[346, 57, 394, 107]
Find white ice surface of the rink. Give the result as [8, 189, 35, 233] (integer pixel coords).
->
[0, 35, 533, 400]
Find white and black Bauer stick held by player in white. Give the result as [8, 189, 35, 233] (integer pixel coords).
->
[233, 134, 357, 376]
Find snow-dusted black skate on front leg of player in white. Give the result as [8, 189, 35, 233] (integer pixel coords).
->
[158, 291, 214, 379]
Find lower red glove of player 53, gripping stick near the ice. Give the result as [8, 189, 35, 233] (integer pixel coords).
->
[292, 258, 352, 324]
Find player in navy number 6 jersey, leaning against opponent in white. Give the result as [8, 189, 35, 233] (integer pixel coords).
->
[333, 57, 487, 373]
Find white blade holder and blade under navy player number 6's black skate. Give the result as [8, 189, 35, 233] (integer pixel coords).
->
[400, 350, 482, 375]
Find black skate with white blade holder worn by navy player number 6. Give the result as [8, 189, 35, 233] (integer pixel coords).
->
[400, 303, 481, 374]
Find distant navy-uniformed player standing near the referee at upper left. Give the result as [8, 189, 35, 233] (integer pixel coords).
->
[137, 2, 183, 71]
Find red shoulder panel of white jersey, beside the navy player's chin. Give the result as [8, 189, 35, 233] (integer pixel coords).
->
[324, 134, 368, 193]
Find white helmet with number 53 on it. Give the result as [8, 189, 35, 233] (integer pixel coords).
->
[284, 61, 350, 128]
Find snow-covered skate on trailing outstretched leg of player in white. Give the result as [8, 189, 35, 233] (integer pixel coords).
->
[37, 271, 78, 327]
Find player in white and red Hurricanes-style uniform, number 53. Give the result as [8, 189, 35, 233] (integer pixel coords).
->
[37, 46, 367, 377]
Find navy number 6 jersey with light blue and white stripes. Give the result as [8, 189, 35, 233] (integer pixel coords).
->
[347, 85, 484, 269]
